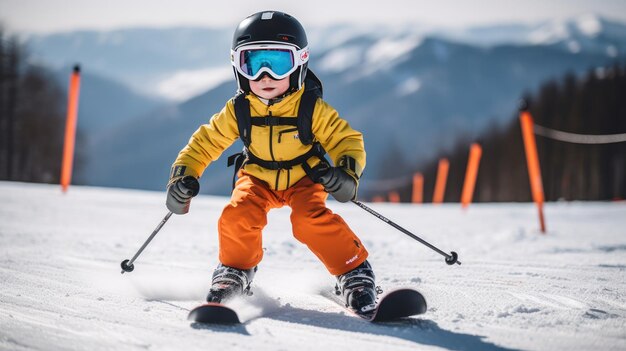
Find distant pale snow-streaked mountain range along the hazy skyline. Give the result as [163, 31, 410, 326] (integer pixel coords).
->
[25, 14, 626, 101]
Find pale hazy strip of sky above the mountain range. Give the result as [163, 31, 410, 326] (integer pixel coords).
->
[0, 0, 626, 32]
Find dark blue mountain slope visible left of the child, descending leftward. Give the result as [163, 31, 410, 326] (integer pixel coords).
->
[83, 82, 242, 194]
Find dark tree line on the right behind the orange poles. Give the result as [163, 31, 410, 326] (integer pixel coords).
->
[378, 64, 626, 202]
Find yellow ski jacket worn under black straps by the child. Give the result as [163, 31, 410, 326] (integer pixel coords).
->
[170, 87, 365, 190]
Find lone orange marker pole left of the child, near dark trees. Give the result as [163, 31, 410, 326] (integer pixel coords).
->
[61, 65, 80, 193]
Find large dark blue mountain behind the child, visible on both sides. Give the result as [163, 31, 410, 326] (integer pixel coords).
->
[88, 31, 624, 196]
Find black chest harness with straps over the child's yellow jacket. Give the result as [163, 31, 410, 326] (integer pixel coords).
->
[228, 70, 328, 188]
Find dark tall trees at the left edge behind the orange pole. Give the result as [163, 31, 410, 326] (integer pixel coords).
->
[0, 28, 81, 183]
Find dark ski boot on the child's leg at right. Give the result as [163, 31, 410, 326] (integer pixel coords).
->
[335, 261, 382, 314]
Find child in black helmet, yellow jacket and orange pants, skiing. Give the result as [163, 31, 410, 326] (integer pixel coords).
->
[166, 11, 376, 312]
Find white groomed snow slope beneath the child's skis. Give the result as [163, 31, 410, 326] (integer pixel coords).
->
[0, 182, 626, 350]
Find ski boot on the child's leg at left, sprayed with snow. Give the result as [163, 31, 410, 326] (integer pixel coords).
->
[206, 263, 257, 303]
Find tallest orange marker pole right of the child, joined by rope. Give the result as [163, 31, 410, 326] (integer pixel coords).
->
[520, 111, 546, 234]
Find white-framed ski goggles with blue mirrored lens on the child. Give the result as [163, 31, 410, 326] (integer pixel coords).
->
[230, 44, 309, 80]
